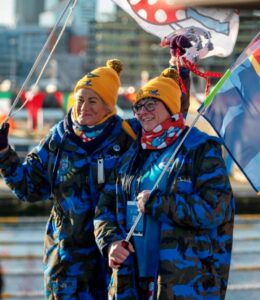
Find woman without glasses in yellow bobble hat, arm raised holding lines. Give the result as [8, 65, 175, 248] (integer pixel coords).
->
[0, 60, 138, 300]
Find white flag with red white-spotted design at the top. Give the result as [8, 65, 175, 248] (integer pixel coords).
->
[113, 0, 239, 57]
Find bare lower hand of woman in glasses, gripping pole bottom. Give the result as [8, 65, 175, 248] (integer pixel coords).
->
[108, 241, 135, 269]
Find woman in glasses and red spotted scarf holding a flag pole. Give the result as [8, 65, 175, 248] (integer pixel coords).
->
[94, 68, 234, 300]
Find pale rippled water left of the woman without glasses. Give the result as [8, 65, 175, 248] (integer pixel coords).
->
[0, 217, 47, 300]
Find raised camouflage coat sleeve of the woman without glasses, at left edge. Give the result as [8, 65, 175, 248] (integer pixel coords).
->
[0, 136, 53, 202]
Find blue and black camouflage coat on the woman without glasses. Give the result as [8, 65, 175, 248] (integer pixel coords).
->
[0, 115, 137, 299]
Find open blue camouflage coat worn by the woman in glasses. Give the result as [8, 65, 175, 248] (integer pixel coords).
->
[94, 128, 234, 300]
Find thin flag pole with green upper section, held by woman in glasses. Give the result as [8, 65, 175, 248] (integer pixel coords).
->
[124, 69, 231, 243]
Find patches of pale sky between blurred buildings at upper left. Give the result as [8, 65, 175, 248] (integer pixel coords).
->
[0, 0, 112, 26]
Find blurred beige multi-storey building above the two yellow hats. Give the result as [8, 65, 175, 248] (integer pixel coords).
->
[87, 8, 169, 87]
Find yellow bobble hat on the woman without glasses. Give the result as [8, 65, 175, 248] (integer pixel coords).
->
[74, 59, 123, 111]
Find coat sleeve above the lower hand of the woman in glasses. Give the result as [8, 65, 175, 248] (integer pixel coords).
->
[94, 171, 124, 257]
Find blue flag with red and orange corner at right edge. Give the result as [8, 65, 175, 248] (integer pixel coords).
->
[199, 33, 260, 192]
